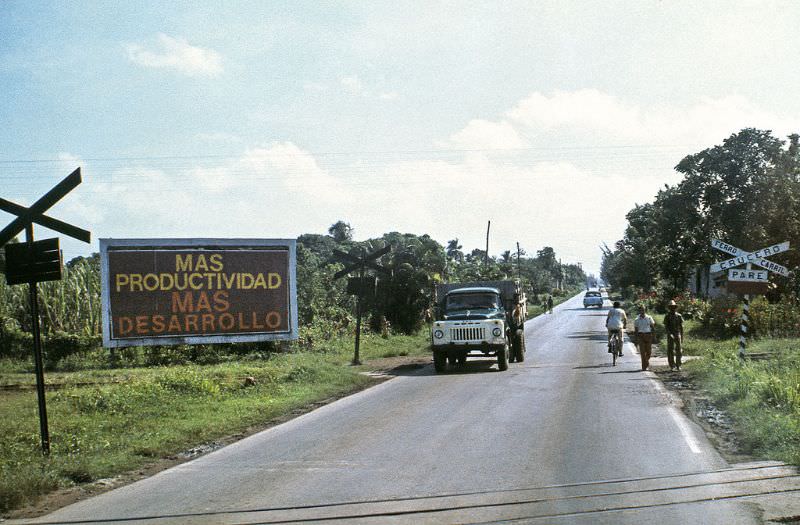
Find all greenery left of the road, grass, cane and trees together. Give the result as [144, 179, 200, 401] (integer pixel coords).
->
[0, 221, 586, 513]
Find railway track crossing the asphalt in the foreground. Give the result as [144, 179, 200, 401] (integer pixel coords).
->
[19, 462, 800, 524]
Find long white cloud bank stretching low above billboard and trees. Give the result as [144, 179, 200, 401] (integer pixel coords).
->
[73, 90, 798, 272]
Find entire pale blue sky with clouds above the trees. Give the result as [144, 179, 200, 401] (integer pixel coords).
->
[0, 0, 800, 274]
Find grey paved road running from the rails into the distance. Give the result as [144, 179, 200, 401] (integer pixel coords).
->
[15, 297, 800, 525]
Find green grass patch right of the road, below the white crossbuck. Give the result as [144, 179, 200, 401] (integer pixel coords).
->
[684, 337, 800, 465]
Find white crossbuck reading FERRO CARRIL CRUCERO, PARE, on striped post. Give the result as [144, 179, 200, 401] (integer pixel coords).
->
[710, 239, 789, 358]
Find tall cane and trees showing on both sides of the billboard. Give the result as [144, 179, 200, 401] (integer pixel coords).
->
[0, 221, 586, 356]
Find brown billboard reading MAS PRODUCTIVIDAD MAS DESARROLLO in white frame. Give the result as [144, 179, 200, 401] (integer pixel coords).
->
[100, 239, 297, 347]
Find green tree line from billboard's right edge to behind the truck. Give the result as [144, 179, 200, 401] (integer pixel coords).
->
[297, 221, 586, 333]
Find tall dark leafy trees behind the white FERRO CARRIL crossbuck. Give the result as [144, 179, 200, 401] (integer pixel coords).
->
[601, 128, 800, 297]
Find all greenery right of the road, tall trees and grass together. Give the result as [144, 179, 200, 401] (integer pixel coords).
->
[601, 129, 800, 464]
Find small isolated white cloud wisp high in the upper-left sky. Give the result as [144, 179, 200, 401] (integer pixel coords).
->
[125, 33, 223, 77]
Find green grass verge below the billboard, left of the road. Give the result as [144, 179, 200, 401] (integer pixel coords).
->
[0, 330, 428, 512]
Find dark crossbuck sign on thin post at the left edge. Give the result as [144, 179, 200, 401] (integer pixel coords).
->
[0, 168, 91, 454]
